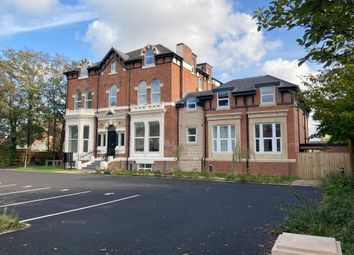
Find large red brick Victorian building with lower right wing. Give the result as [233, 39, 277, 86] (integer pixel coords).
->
[65, 43, 307, 175]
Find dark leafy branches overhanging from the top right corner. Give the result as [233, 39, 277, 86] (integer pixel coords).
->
[254, 0, 354, 67]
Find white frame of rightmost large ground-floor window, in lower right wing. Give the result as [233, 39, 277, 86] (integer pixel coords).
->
[254, 122, 283, 154]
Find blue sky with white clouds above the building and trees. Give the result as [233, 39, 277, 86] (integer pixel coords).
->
[0, 0, 317, 132]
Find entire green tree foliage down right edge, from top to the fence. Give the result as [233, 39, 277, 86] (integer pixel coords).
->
[254, 0, 354, 171]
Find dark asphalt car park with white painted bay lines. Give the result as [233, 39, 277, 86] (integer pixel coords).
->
[0, 170, 319, 255]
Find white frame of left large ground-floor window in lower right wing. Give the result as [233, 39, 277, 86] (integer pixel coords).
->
[212, 124, 236, 154]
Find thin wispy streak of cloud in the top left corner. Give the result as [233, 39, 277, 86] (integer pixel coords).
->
[0, 0, 95, 37]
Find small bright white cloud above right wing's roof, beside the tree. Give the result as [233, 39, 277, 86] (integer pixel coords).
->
[262, 58, 314, 85]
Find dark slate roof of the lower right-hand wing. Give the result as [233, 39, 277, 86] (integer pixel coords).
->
[220, 75, 299, 94]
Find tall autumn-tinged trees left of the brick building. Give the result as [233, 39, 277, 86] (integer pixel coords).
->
[0, 49, 68, 163]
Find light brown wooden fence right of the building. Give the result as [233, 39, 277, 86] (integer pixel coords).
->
[297, 152, 352, 179]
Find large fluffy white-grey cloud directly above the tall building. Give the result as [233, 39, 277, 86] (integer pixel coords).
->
[82, 0, 281, 77]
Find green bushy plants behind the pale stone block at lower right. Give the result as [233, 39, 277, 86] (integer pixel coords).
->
[278, 174, 354, 255]
